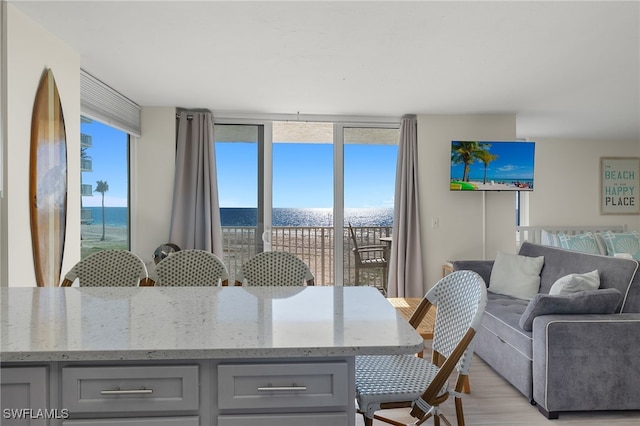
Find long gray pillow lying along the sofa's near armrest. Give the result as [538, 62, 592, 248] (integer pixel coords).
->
[520, 288, 622, 331]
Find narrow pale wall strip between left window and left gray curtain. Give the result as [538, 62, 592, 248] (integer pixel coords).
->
[131, 107, 176, 263]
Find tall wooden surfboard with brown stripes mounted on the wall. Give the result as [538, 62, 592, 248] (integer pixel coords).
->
[29, 69, 67, 287]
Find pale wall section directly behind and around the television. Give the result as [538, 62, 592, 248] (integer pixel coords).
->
[418, 114, 516, 290]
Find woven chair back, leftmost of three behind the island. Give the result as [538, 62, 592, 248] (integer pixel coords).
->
[60, 250, 147, 287]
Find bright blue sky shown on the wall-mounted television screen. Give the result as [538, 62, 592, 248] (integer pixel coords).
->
[451, 142, 535, 181]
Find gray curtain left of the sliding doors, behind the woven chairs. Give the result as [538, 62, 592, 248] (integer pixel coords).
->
[169, 111, 223, 259]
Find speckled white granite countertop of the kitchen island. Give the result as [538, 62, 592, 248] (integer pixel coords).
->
[0, 287, 423, 363]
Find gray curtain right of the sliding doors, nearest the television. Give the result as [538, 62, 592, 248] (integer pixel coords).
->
[388, 115, 424, 297]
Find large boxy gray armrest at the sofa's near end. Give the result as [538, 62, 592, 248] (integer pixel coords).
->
[533, 313, 640, 413]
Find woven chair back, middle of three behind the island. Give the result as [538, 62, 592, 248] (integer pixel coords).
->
[155, 249, 229, 286]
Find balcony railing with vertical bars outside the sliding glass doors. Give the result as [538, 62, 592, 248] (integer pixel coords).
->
[222, 226, 391, 287]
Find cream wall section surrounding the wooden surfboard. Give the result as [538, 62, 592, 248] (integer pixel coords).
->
[0, 4, 80, 286]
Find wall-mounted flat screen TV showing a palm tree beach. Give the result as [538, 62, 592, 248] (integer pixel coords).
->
[449, 141, 535, 191]
